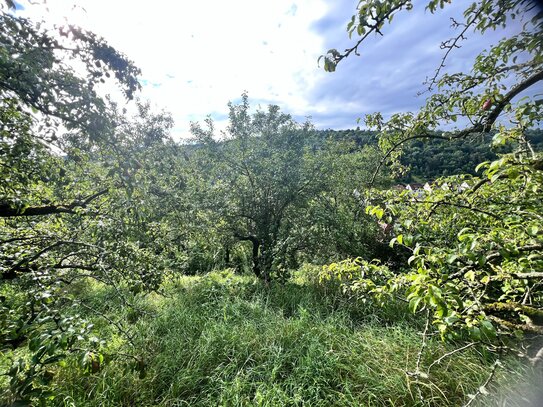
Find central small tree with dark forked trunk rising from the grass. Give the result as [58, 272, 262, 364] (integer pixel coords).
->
[192, 94, 348, 280]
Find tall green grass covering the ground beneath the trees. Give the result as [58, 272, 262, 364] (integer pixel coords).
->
[23, 272, 532, 406]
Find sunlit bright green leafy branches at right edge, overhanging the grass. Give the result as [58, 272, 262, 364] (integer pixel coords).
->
[368, 154, 543, 339]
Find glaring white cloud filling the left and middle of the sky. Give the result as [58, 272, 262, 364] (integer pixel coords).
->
[17, 0, 326, 136]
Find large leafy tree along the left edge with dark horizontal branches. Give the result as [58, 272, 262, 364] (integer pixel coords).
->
[0, 1, 171, 402]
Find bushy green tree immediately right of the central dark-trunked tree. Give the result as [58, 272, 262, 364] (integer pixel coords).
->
[290, 140, 392, 264]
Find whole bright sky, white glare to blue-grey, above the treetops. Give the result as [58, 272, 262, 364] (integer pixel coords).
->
[14, 0, 536, 139]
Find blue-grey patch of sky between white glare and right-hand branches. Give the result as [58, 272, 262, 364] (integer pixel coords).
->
[309, 0, 520, 127]
